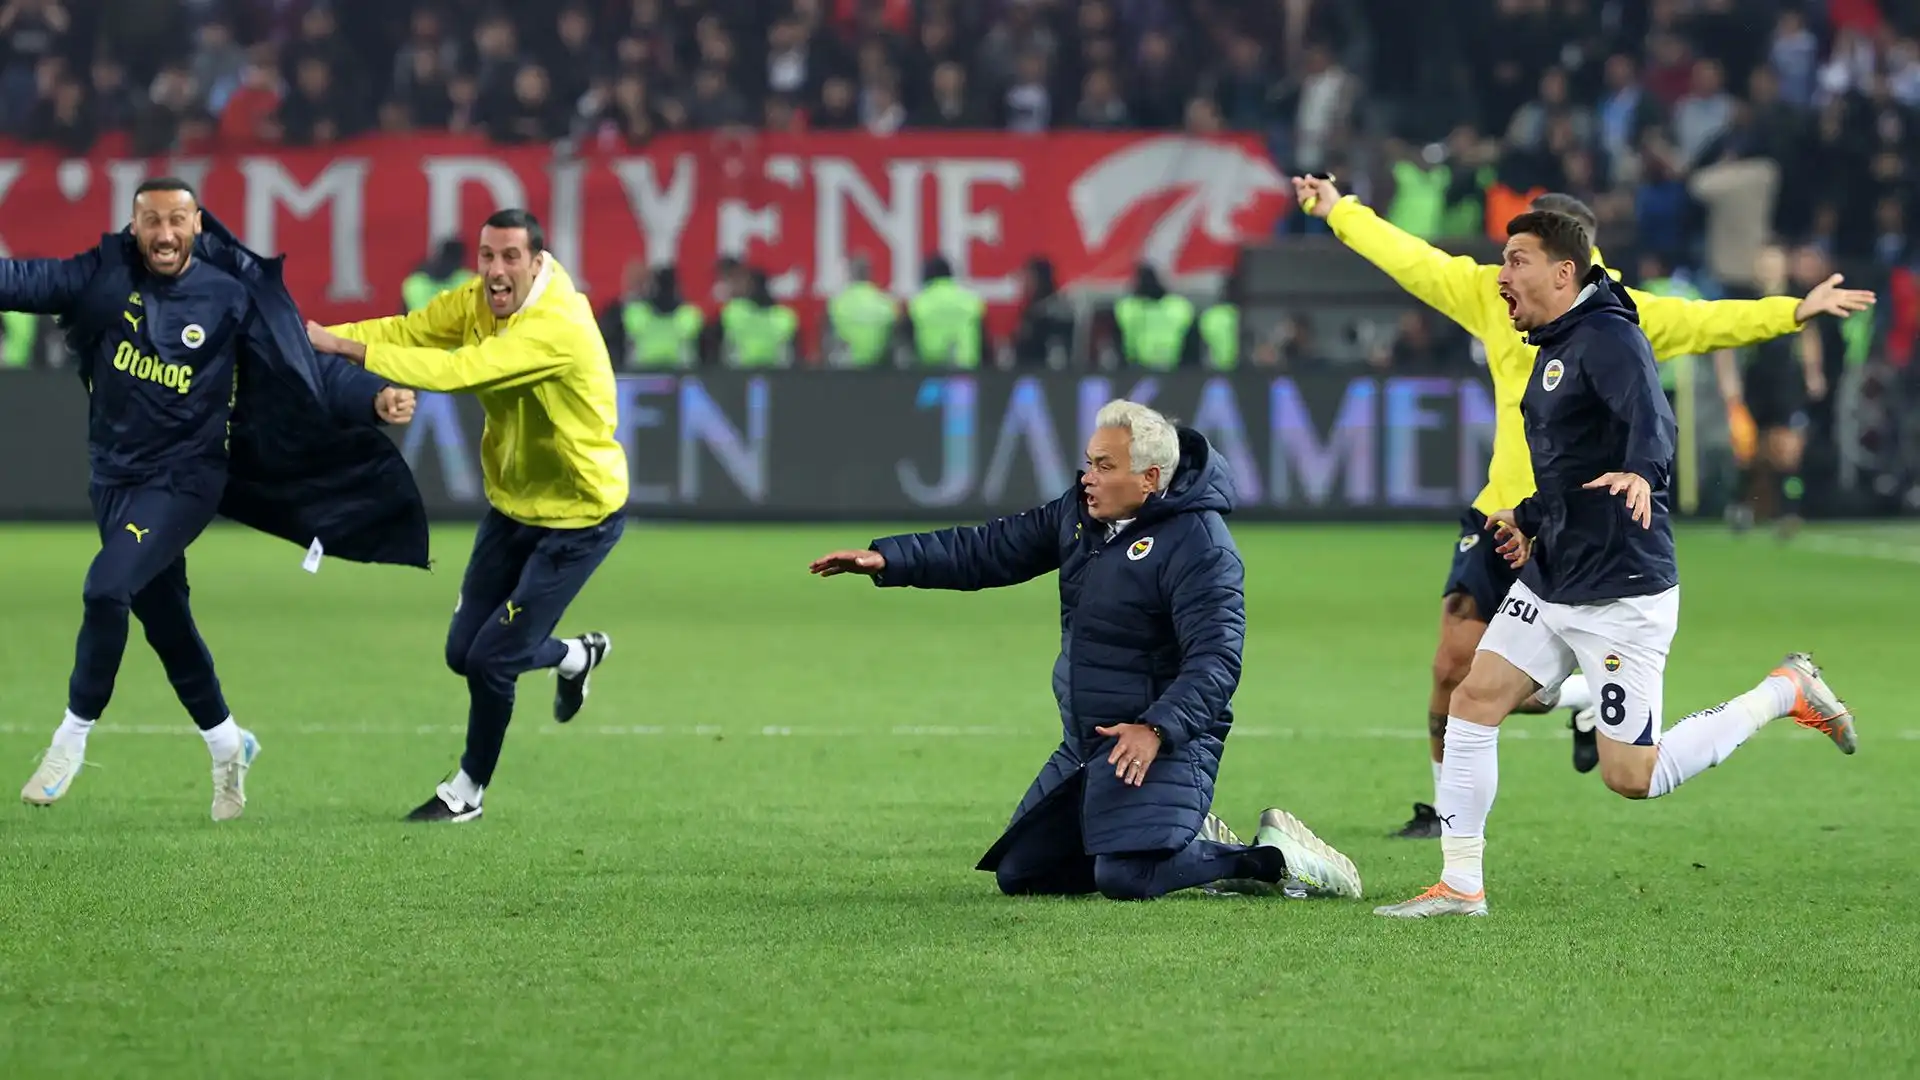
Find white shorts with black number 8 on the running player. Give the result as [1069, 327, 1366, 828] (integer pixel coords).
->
[1480, 582, 1680, 746]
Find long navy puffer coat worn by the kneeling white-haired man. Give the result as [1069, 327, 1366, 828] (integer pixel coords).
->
[872, 429, 1246, 853]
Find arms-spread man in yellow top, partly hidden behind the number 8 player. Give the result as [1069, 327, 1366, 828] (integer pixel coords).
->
[1294, 177, 1874, 840]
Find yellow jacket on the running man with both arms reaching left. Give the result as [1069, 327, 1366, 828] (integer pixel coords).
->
[328, 261, 628, 528]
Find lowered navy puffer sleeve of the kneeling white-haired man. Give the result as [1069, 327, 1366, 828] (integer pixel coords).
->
[1140, 548, 1246, 748]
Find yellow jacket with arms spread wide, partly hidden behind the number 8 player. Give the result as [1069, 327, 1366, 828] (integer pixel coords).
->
[1327, 196, 1799, 513]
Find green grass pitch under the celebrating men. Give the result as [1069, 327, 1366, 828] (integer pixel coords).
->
[0, 523, 1920, 1080]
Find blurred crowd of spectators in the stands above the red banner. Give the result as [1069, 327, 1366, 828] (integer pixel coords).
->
[0, 0, 1920, 367]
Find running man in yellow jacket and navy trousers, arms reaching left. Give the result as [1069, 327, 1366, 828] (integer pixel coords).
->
[307, 209, 628, 822]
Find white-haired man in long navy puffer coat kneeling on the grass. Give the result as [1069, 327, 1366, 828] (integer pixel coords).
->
[812, 402, 1361, 899]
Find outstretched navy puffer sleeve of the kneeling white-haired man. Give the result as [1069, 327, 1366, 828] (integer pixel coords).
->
[872, 496, 1075, 592]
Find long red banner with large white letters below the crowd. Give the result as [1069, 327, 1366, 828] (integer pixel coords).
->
[0, 133, 1290, 343]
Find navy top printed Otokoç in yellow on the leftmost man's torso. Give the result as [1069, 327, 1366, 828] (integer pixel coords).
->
[86, 269, 248, 482]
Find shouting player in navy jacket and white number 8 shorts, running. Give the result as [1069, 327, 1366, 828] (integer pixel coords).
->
[1375, 211, 1855, 919]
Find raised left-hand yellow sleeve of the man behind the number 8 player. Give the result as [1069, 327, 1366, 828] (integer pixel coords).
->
[1327, 196, 1513, 340]
